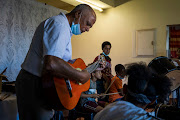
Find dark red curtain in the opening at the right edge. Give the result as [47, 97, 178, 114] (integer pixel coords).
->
[169, 26, 180, 58]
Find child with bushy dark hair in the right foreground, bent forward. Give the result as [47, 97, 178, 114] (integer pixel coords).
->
[94, 62, 171, 120]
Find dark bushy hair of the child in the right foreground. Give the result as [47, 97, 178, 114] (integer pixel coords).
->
[126, 62, 171, 102]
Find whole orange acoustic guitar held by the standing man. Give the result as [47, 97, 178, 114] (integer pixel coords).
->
[42, 58, 102, 110]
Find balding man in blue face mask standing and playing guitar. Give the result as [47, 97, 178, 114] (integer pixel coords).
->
[16, 4, 96, 120]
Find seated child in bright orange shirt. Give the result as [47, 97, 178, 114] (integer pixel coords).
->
[109, 64, 125, 102]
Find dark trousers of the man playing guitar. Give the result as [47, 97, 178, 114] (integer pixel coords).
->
[16, 70, 54, 120]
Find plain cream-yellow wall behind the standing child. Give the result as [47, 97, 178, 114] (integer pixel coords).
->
[72, 0, 180, 74]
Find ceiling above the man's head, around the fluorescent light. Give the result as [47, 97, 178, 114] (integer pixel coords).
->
[37, 0, 130, 11]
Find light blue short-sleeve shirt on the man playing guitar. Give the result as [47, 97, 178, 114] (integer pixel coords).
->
[21, 13, 72, 77]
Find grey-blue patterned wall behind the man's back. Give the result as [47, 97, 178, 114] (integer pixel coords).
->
[0, 0, 60, 81]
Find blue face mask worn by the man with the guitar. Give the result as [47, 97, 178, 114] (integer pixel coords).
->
[71, 15, 81, 35]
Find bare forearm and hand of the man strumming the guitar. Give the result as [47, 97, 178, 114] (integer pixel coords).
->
[42, 55, 90, 83]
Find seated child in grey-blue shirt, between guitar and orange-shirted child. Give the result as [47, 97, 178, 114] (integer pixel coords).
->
[79, 68, 105, 113]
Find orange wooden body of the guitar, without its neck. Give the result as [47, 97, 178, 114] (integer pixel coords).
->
[43, 58, 90, 110]
